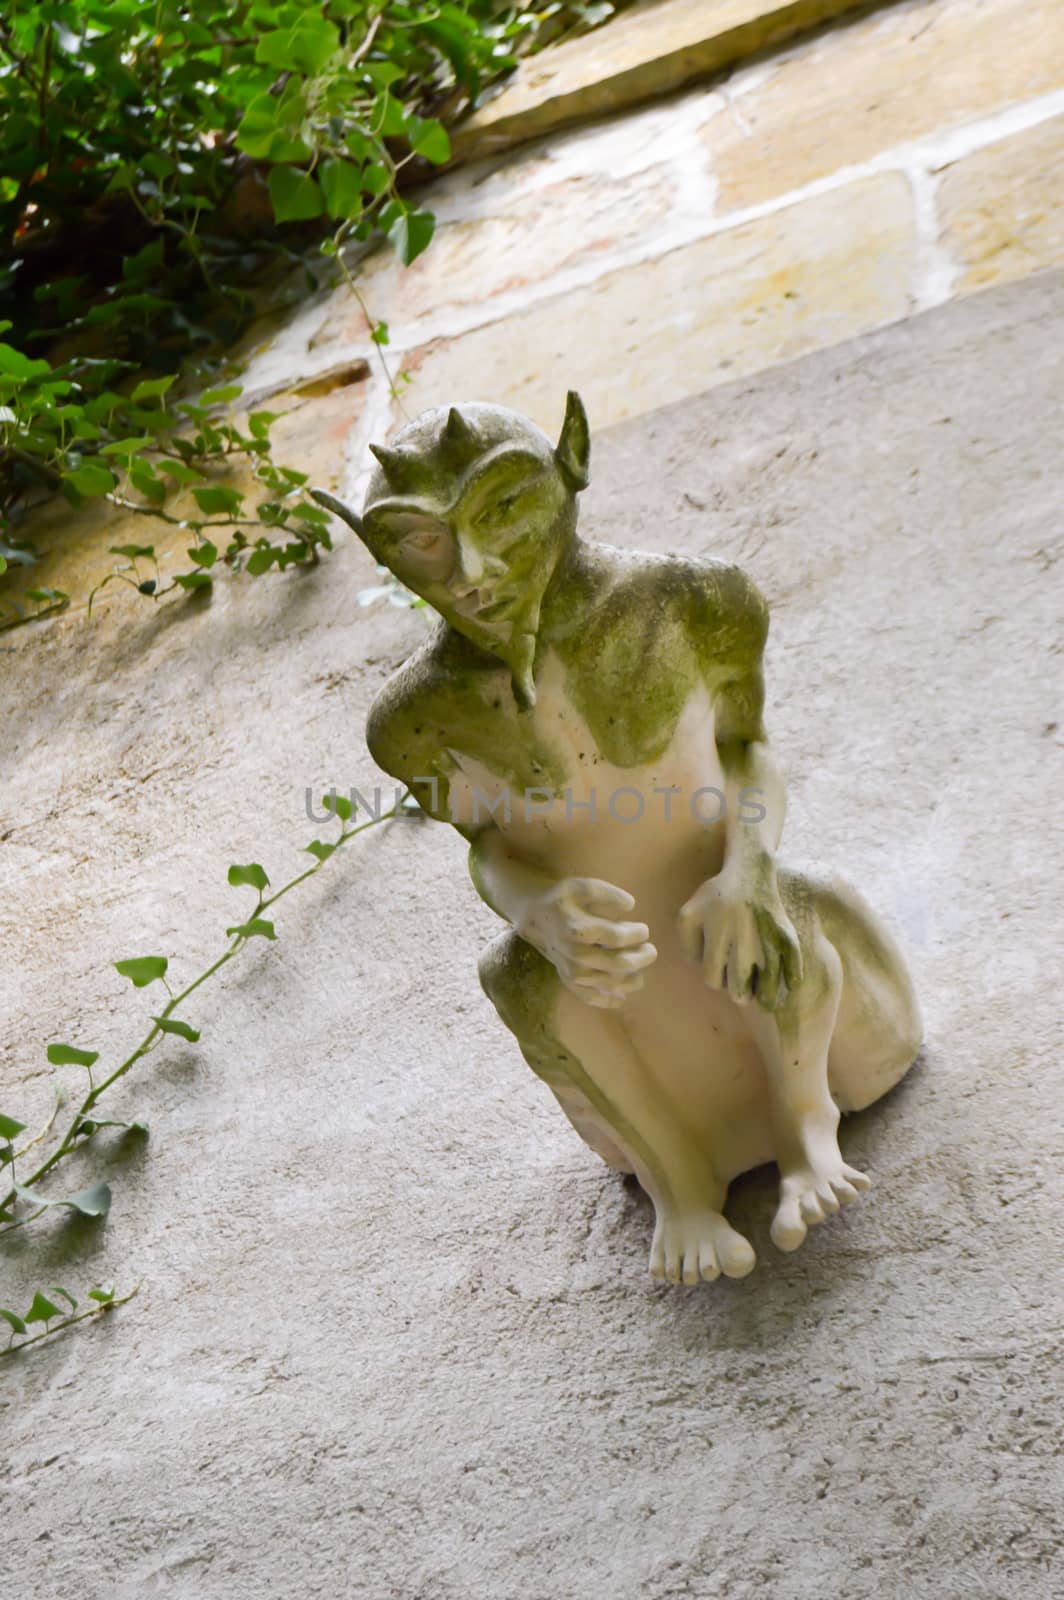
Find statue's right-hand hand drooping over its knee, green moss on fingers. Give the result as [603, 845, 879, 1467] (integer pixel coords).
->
[680, 869, 802, 1011]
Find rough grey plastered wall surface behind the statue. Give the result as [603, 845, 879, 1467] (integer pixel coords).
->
[0, 274, 1064, 1600]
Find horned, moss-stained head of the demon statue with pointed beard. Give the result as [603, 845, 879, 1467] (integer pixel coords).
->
[362, 392, 590, 690]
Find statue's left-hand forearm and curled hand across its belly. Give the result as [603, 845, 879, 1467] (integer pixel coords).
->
[469, 822, 658, 1010]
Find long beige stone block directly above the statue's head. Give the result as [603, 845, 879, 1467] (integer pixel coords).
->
[393, 173, 917, 429]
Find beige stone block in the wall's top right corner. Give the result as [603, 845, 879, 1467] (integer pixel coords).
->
[702, 0, 1064, 213]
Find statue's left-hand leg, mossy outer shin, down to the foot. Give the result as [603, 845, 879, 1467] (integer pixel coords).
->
[480, 933, 755, 1283]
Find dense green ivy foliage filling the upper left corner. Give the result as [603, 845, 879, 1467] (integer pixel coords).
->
[0, 0, 614, 627]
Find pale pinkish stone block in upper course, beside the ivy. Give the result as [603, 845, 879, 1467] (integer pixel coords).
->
[310, 162, 680, 350]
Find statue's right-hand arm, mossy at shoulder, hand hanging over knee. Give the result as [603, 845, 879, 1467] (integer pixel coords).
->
[680, 568, 802, 1010]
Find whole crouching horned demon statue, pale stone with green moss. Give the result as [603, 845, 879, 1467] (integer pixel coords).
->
[322, 394, 920, 1283]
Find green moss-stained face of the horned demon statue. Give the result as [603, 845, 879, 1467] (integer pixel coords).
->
[363, 408, 576, 654]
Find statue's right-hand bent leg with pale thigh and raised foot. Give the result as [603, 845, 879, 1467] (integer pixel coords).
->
[742, 872, 920, 1250]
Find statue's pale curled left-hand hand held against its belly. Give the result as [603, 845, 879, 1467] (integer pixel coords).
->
[517, 878, 658, 1010]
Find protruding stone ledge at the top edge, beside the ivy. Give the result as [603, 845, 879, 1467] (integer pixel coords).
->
[453, 0, 867, 160]
